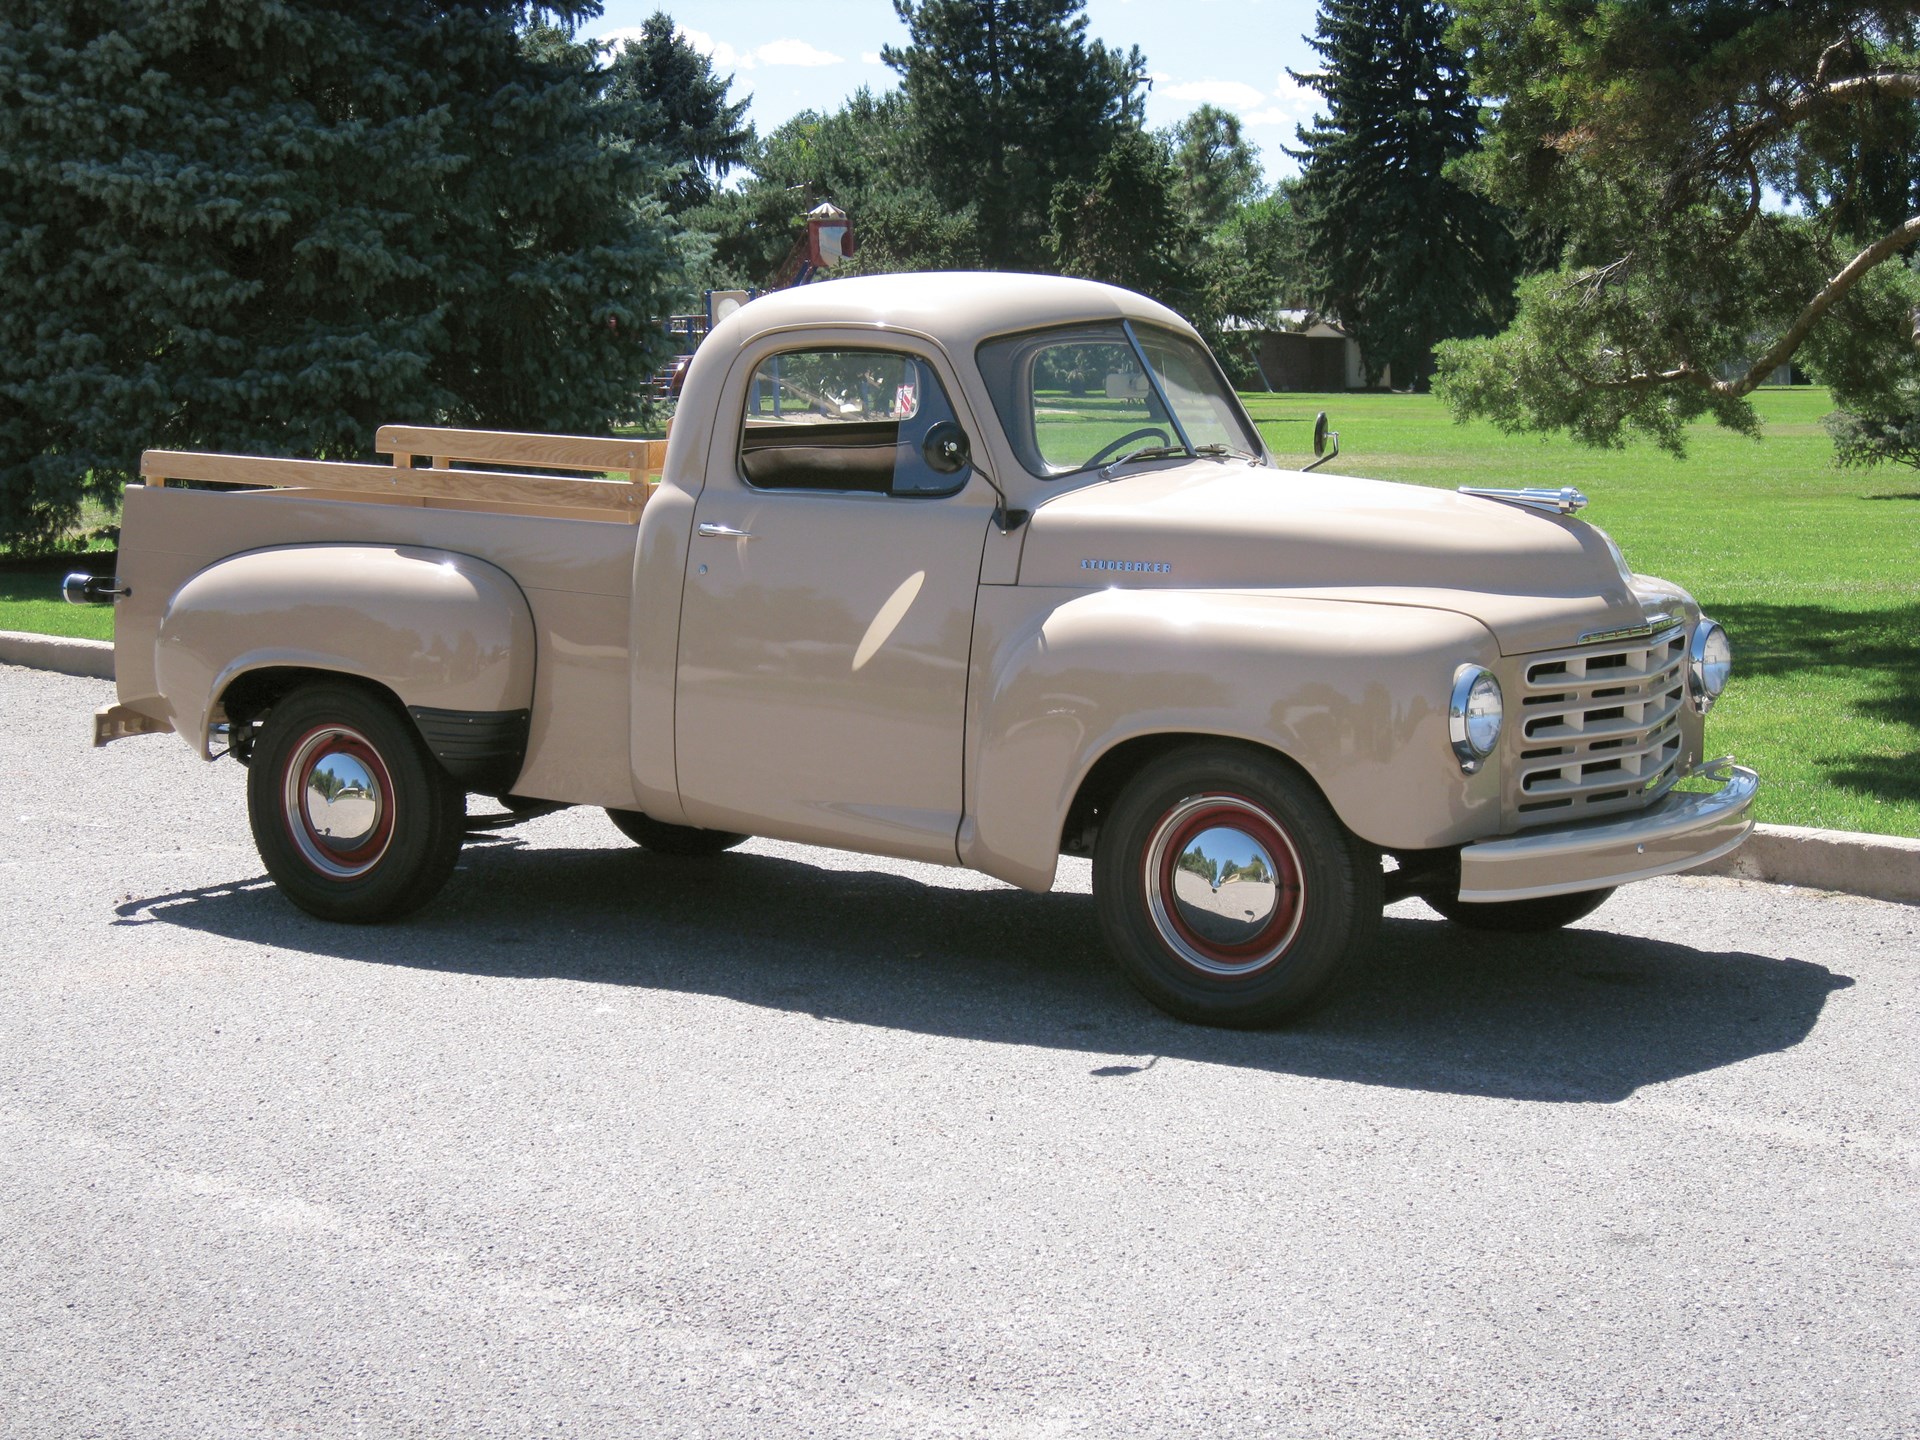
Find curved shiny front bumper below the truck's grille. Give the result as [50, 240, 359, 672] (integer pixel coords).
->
[1459, 758, 1761, 904]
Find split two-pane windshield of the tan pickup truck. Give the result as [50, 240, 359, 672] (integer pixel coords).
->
[979, 321, 1263, 480]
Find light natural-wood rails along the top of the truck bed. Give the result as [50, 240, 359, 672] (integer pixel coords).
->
[140, 424, 666, 520]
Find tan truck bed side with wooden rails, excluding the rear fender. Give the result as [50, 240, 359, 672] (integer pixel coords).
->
[115, 426, 664, 806]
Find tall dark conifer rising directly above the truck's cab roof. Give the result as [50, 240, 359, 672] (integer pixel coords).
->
[881, 0, 1146, 269]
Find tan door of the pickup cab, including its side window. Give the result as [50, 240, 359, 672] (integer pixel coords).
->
[674, 340, 998, 864]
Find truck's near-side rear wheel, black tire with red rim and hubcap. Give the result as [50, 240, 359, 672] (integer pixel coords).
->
[246, 682, 467, 924]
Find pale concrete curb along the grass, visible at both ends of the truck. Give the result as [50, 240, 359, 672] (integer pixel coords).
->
[0, 630, 1920, 904]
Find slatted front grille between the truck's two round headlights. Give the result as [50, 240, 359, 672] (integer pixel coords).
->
[1505, 626, 1686, 826]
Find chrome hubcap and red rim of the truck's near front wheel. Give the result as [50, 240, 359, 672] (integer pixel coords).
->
[1142, 795, 1304, 975]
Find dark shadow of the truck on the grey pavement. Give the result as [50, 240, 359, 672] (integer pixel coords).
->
[115, 841, 1853, 1102]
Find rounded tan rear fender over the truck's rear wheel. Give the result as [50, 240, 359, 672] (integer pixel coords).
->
[154, 545, 534, 756]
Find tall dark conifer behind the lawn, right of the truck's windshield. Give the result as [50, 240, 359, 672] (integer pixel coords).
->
[1288, 0, 1517, 384]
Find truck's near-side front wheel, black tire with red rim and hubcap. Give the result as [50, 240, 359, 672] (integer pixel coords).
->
[1092, 743, 1382, 1029]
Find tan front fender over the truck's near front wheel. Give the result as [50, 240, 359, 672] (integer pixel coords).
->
[960, 588, 1500, 889]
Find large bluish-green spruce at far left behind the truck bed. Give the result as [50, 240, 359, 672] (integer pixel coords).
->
[0, 0, 672, 541]
